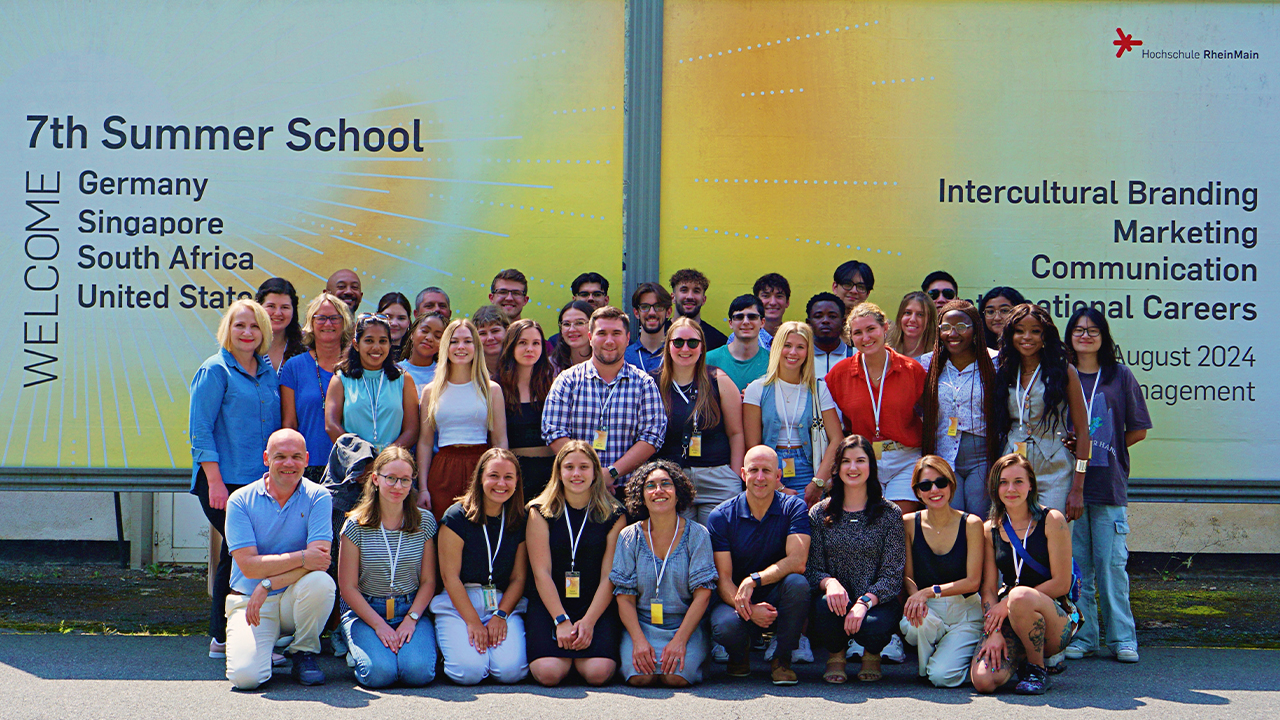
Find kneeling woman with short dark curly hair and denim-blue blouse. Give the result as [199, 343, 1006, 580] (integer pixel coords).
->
[609, 460, 717, 688]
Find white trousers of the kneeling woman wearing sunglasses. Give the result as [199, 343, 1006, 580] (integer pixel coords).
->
[899, 593, 982, 688]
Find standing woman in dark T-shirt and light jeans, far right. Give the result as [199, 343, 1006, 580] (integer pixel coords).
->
[1066, 307, 1151, 662]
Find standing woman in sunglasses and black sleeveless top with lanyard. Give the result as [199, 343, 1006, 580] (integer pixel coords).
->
[654, 318, 746, 525]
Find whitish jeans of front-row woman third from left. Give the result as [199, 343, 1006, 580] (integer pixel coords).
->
[431, 585, 529, 685]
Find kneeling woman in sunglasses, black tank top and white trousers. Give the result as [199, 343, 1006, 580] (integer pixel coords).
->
[899, 455, 983, 688]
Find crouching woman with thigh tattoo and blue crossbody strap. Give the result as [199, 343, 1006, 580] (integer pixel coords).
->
[970, 454, 1079, 694]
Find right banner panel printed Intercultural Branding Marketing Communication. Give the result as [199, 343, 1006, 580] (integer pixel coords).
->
[662, 0, 1280, 480]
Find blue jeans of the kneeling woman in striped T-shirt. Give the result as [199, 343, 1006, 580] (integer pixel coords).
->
[342, 594, 436, 688]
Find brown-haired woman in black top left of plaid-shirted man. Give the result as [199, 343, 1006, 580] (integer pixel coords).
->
[493, 318, 556, 497]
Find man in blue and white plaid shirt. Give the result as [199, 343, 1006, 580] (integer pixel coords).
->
[543, 306, 667, 488]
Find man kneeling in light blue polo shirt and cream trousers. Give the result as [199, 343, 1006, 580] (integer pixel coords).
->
[225, 429, 335, 691]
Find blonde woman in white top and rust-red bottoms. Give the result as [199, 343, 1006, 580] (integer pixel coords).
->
[417, 319, 507, 519]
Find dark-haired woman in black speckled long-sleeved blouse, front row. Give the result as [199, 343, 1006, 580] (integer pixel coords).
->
[804, 436, 906, 684]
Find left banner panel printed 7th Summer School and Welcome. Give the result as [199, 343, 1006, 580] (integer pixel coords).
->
[0, 0, 625, 469]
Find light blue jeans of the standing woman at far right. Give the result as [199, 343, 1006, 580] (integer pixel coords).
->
[1071, 503, 1138, 652]
